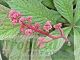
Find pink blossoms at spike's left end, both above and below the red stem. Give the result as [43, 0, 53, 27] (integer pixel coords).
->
[9, 10, 33, 35]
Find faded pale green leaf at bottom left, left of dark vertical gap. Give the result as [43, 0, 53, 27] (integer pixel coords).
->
[3, 36, 30, 60]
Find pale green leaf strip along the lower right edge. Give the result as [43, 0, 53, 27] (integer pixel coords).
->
[74, 28, 80, 60]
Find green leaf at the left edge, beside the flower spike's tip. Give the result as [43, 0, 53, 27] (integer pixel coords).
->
[0, 4, 19, 40]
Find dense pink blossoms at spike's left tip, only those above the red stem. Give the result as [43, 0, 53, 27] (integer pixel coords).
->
[9, 10, 32, 25]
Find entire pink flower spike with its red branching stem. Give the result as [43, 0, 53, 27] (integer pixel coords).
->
[9, 10, 68, 48]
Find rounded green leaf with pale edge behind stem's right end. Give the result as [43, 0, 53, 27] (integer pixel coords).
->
[40, 27, 71, 56]
